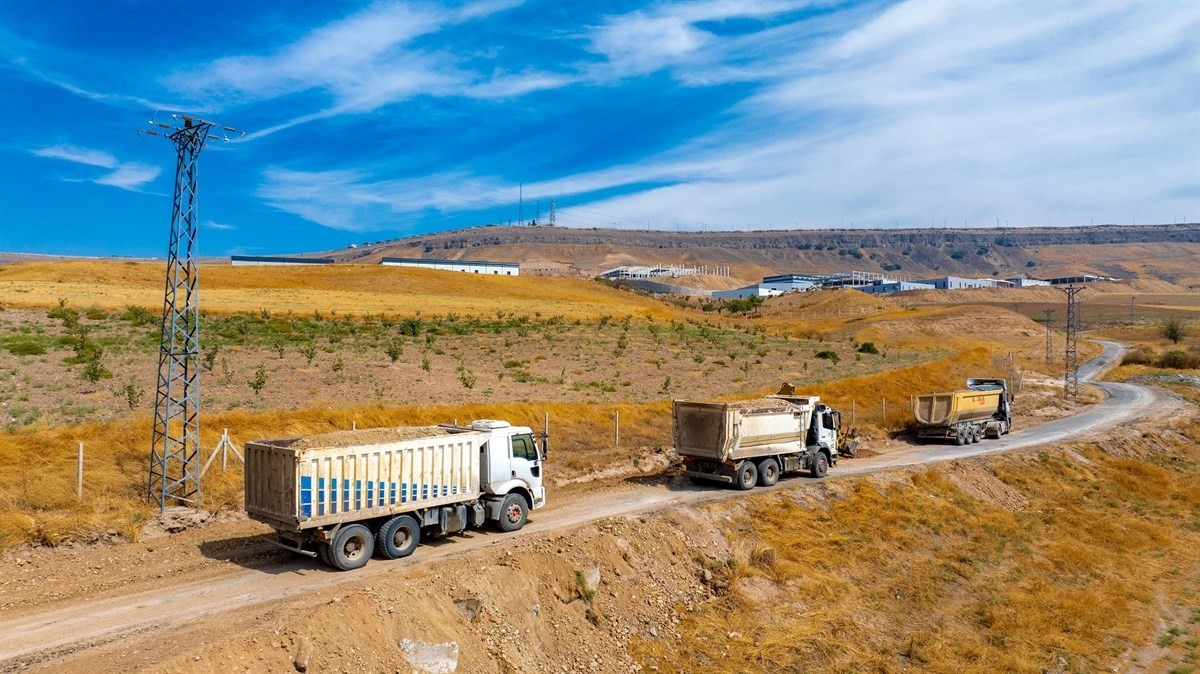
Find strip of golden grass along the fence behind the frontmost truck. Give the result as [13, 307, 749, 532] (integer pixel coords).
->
[0, 403, 671, 550]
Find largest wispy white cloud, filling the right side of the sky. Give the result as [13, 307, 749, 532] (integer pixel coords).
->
[559, 2, 1200, 228]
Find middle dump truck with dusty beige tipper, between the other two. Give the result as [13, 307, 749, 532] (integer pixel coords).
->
[674, 384, 858, 489]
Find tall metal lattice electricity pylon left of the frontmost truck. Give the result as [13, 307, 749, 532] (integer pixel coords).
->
[138, 115, 240, 512]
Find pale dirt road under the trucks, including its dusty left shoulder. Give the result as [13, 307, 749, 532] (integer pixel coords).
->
[0, 342, 1166, 670]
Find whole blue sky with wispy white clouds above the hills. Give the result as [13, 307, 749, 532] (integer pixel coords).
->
[0, 0, 1200, 255]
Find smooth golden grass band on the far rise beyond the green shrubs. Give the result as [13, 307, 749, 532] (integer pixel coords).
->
[0, 261, 685, 319]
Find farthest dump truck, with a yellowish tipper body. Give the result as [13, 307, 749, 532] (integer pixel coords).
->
[912, 378, 1013, 445]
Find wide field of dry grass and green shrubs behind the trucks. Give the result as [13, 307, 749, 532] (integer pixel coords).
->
[0, 261, 1142, 548]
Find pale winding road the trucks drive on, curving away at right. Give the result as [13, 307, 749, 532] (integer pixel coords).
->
[0, 342, 1165, 670]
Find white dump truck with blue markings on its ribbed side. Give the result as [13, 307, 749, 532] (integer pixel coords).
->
[245, 420, 547, 571]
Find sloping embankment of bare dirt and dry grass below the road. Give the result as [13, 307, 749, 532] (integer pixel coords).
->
[4, 388, 1200, 673]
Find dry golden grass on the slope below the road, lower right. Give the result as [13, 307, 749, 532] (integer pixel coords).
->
[631, 413, 1200, 674]
